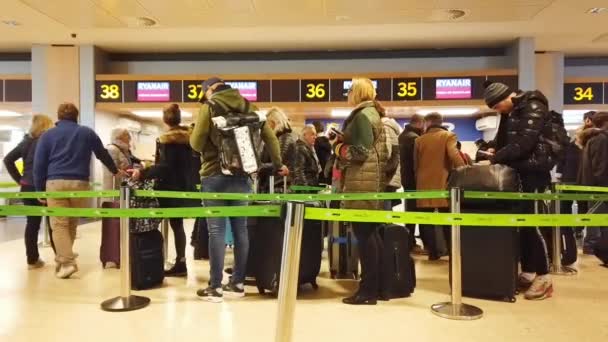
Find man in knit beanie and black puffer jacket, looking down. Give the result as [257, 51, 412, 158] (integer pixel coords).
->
[484, 82, 554, 300]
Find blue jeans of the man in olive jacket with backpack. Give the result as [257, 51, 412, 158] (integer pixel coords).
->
[201, 175, 251, 288]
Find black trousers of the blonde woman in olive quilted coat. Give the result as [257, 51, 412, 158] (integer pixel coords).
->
[352, 223, 384, 298]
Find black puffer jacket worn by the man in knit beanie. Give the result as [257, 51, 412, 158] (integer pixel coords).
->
[494, 90, 555, 172]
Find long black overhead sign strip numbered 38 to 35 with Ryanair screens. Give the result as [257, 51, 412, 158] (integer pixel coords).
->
[95, 75, 517, 103]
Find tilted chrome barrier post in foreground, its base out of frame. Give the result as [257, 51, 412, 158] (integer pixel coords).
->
[275, 202, 305, 342]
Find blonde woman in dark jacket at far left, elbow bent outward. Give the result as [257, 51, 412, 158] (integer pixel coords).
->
[4, 114, 54, 269]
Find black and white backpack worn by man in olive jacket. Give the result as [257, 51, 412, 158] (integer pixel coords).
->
[207, 99, 266, 175]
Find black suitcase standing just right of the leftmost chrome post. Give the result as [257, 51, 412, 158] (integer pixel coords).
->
[131, 230, 165, 290]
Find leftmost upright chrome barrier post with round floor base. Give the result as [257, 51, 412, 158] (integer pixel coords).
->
[101, 186, 150, 312]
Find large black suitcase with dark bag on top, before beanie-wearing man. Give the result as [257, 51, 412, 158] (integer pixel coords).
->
[448, 165, 520, 302]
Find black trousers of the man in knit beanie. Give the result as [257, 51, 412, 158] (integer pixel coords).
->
[519, 175, 550, 275]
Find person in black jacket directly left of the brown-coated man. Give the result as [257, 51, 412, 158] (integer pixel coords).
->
[399, 114, 424, 253]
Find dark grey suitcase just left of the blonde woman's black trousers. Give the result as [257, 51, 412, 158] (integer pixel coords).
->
[327, 221, 359, 279]
